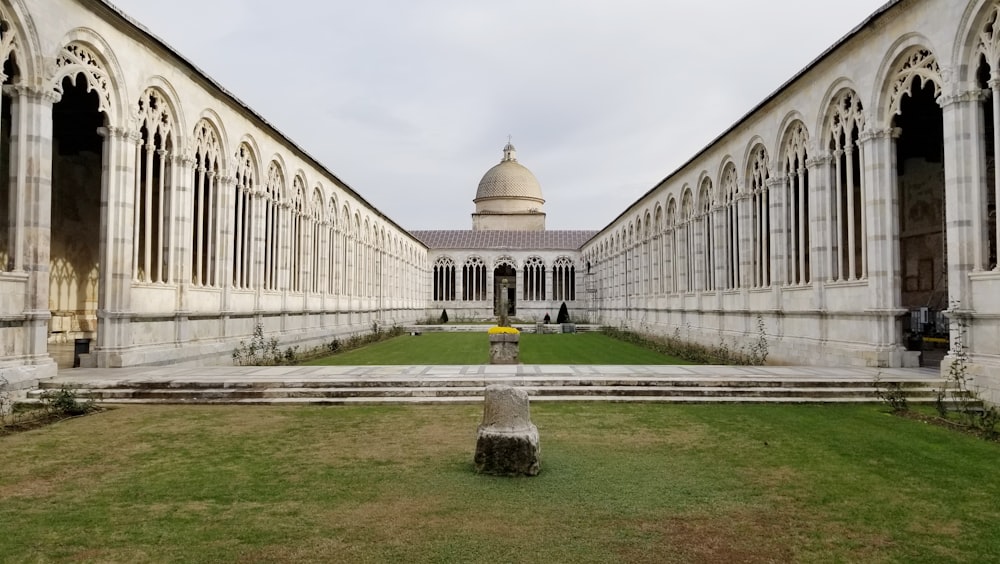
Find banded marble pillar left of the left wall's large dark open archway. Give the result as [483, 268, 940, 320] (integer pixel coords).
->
[5, 82, 59, 366]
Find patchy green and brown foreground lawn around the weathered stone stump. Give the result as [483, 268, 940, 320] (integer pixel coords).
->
[0, 403, 1000, 563]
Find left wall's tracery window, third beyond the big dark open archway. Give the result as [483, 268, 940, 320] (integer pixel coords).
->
[233, 143, 257, 289]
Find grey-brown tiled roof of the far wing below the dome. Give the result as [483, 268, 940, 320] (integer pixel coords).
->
[410, 230, 597, 251]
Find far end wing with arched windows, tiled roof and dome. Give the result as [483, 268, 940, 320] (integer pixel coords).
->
[411, 141, 597, 321]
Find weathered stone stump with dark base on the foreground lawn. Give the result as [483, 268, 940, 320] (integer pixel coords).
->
[475, 384, 541, 476]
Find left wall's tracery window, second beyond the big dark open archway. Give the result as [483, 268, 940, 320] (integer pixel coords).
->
[191, 119, 222, 286]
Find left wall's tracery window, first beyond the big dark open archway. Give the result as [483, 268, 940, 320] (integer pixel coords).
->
[132, 88, 175, 283]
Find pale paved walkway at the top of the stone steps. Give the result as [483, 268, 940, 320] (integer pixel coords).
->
[41, 364, 941, 387]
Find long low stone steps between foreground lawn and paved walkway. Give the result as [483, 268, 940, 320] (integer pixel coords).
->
[28, 367, 972, 405]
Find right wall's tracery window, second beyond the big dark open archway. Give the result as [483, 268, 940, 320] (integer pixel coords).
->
[784, 122, 809, 284]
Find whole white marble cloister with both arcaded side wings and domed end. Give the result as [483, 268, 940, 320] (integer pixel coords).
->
[0, 0, 1000, 401]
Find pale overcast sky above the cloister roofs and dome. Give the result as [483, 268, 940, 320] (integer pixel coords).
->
[111, 0, 885, 230]
